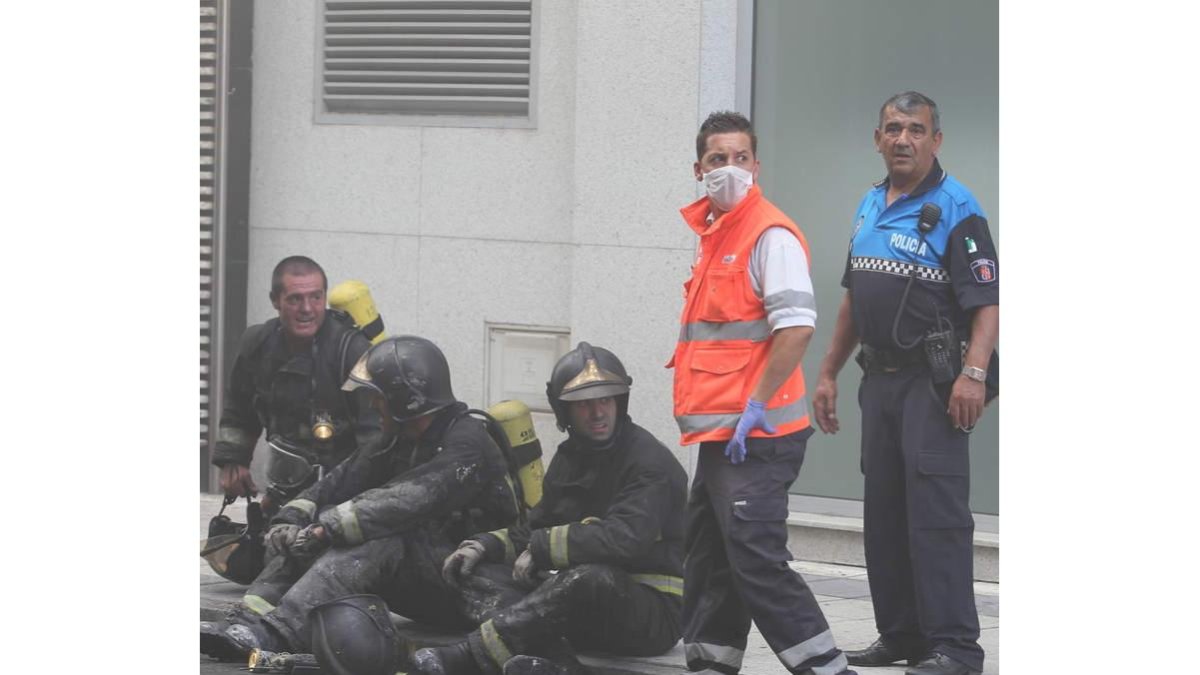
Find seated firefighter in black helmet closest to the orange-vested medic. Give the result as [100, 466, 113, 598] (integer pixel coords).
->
[410, 342, 688, 675]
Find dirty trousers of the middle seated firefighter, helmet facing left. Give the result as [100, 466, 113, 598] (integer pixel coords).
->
[245, 530, 522, 652]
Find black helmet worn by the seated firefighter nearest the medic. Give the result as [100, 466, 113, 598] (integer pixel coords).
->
[546, 342, 634, 431]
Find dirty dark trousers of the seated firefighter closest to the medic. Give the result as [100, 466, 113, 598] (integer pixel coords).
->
[468, 563, 680, 673]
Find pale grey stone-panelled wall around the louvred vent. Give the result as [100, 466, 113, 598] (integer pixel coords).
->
[248, 0, 737, 470]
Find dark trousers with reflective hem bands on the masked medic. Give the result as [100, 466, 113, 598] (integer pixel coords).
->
[683, 428, 847, 675]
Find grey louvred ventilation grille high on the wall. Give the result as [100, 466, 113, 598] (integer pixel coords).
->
[322, 0, 533, 117]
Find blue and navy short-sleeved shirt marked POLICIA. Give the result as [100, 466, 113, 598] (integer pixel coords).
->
[841, 160, 1000, 350]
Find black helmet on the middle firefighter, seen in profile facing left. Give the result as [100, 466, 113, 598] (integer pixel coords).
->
[342, 335, 455, 422]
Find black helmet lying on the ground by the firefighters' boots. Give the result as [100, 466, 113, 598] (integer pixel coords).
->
[308, 595, 400, 675]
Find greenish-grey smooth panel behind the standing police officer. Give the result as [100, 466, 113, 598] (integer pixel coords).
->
[751, 0, 1003, 513]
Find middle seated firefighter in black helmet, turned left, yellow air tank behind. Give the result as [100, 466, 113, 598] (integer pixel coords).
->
[200, 335, 520, 661]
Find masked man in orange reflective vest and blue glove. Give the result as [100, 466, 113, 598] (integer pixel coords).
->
[673, 113, 853, 675]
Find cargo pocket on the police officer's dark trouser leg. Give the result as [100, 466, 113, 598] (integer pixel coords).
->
[908, 448, 974, 530]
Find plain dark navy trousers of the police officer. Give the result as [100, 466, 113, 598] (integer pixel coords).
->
[858, 363, 984, 670]
